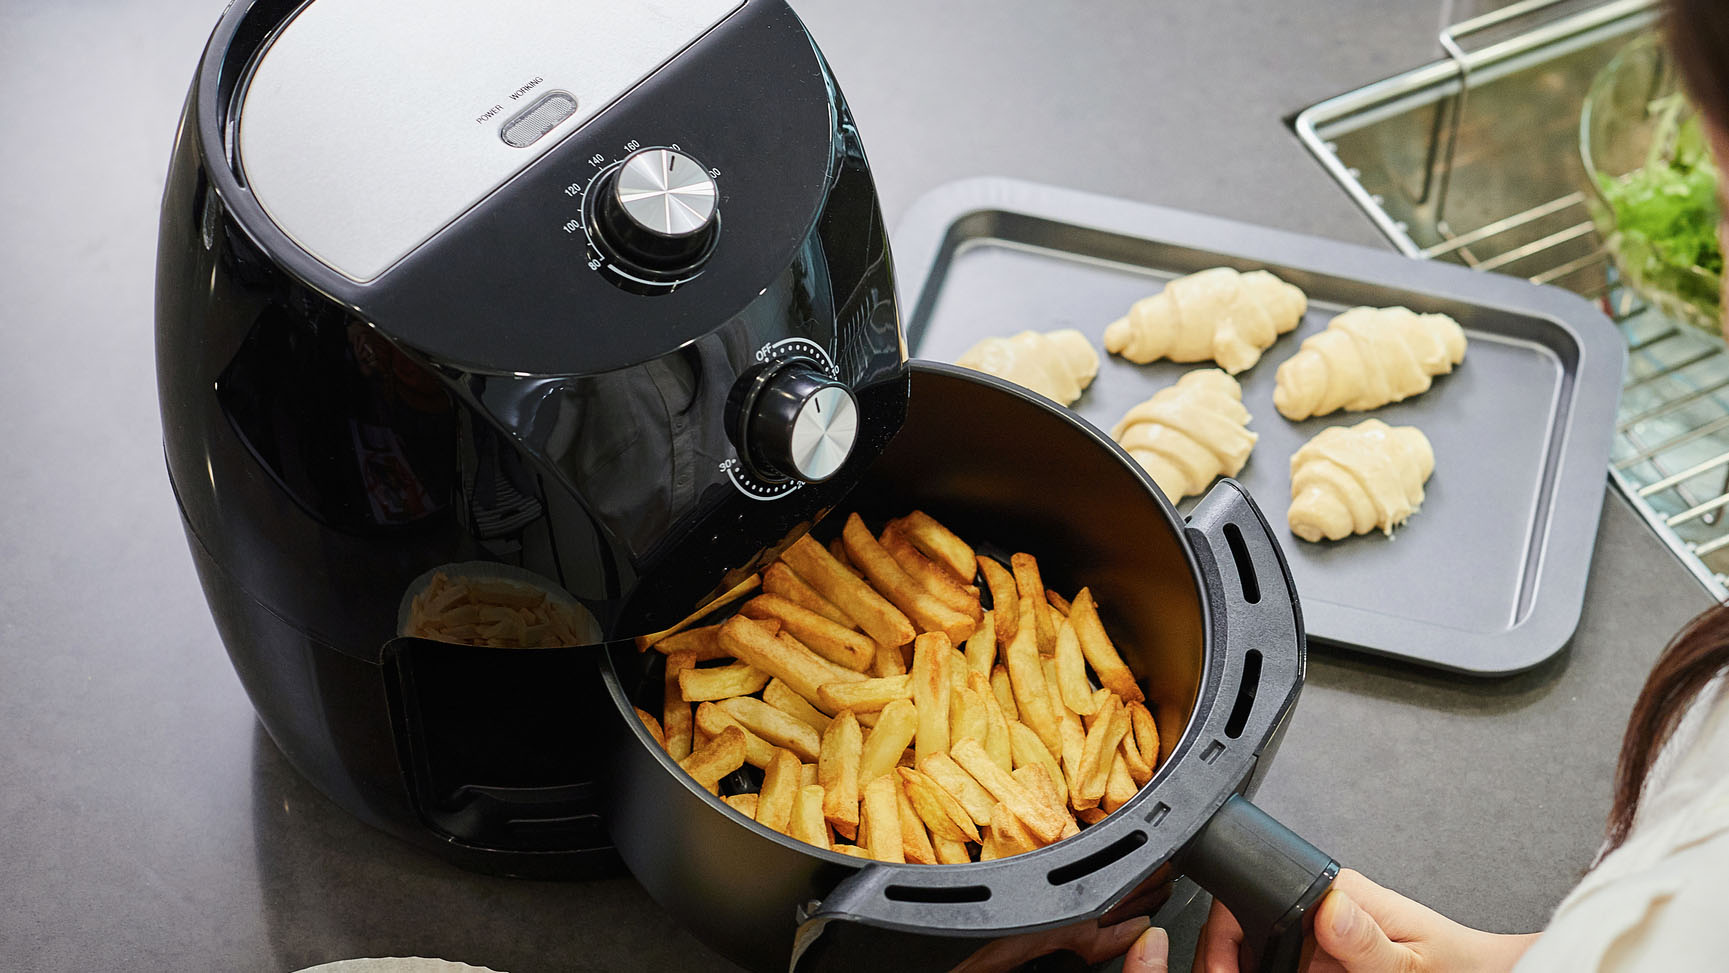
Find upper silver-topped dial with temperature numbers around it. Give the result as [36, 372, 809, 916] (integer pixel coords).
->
[586, 149, 719, 282]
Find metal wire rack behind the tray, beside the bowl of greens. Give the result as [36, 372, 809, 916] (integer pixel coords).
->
[1295, 0, 1729, 598]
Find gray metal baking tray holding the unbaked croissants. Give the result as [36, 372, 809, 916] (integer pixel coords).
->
[894, 178, 1625, 676]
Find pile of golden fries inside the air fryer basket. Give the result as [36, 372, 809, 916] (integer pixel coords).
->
[636, 510, 1158, 864]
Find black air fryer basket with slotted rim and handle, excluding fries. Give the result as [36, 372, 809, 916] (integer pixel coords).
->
[605, 361, 1337, 970]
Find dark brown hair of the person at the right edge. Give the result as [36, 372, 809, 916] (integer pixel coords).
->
[1603, 0, 1729, 854]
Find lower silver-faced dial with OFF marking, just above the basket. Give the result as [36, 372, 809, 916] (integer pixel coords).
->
[738, 361, 859, 484]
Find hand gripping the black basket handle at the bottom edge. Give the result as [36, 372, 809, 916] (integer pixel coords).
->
[1189, 868, 1537, 973]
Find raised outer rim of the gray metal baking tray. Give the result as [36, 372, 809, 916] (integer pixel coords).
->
[890, 176, 1627, 676]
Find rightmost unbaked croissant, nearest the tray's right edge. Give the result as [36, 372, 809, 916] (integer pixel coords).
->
[1273, 308, 1464, 422]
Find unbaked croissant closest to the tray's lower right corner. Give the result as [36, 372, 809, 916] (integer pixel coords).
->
[1290, 418, 1435, 541]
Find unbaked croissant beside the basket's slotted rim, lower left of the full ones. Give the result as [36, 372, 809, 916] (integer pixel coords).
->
[1110, 368, 1257, 503]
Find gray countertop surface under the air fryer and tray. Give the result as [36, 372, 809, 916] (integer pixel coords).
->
[0, 0, 1708, 973]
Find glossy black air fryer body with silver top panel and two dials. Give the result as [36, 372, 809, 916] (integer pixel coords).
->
[157, 0, 908, 874]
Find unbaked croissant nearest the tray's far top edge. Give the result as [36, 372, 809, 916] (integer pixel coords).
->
[1105, 266, 1309, 375]
